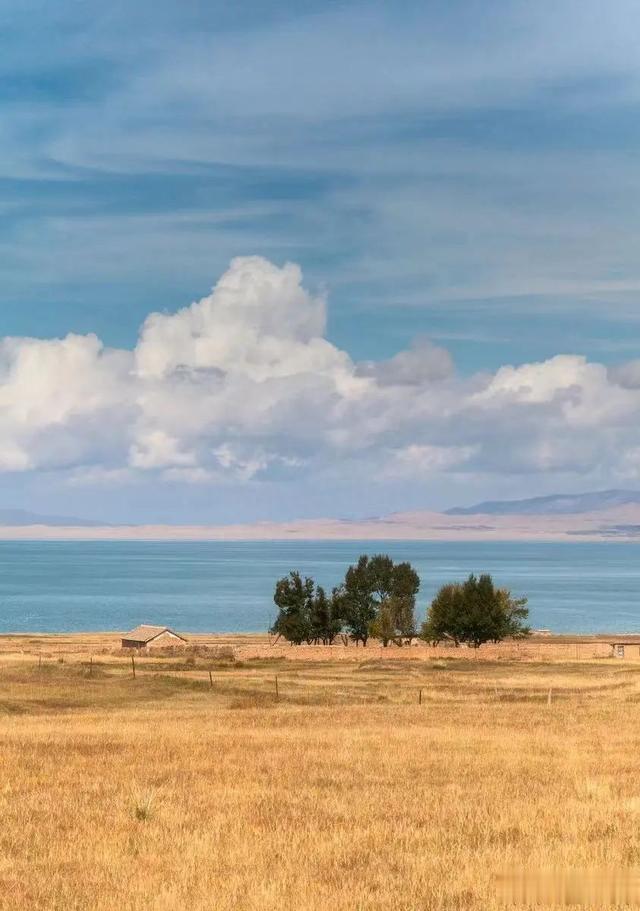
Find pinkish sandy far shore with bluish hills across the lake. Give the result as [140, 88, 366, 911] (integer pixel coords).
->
[0, 490, 640, 541]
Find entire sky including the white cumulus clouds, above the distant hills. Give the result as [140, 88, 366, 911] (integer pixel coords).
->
[0, 0, 640, 523]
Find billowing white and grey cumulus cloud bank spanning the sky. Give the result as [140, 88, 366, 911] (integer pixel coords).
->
[0, 257, 640, 492]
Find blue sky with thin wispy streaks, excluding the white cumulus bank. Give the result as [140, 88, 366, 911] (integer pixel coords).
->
[0, 0, 640, 521]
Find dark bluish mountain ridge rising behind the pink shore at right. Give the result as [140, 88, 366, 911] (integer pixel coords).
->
[445, 490, 640, 516]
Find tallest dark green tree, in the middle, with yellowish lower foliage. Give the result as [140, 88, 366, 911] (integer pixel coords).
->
[336, 554, 420, 646]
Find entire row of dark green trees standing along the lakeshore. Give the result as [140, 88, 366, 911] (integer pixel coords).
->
[270, 554, 530, 648]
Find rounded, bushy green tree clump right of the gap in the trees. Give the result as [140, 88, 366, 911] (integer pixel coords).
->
[420, 575, 530, 648]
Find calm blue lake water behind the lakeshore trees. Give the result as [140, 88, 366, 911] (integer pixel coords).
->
[0, 541, 640, 633]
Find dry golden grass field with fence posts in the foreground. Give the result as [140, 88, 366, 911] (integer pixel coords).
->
[0, 637, 640, 911]
